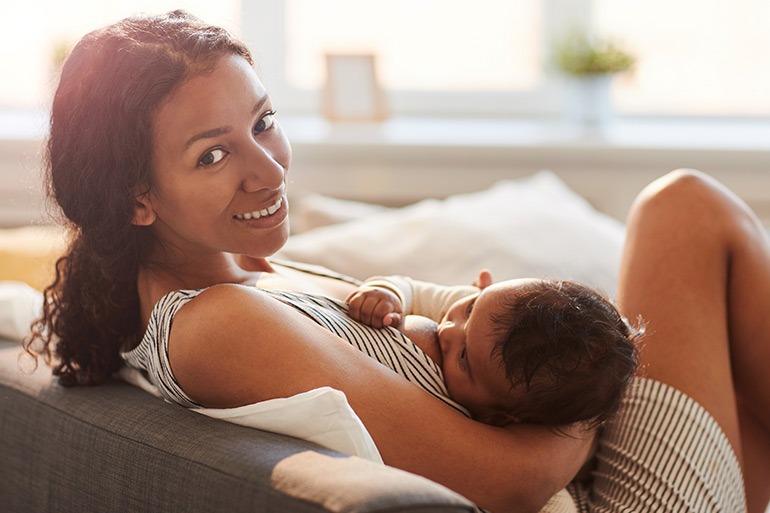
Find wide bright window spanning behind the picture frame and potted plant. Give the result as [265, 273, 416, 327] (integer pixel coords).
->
[243, 0, 770, 117]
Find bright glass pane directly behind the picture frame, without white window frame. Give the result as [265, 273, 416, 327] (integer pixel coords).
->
[286, 0, 542, 91]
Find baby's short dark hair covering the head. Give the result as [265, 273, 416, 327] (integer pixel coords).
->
[492, 280, 644, 427]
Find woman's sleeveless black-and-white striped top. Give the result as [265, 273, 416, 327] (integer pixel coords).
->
[122, 289, 469, 415]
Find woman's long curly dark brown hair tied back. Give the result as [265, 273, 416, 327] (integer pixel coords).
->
[25, 11, 253, 386]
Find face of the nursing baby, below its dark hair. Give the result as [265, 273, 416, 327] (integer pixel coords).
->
[438, 279, 531, 420]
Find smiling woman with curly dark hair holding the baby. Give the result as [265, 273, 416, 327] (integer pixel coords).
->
[28, 12, 770, 512]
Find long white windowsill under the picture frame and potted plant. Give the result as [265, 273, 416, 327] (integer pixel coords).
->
[0, 109, 770, 152]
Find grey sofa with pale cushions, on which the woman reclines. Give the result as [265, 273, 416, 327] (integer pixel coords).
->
[0, 171, 623, 513]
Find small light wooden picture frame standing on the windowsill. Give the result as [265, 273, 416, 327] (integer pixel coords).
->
[323, 54, 387, 122]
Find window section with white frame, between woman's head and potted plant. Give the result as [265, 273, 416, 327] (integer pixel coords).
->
[242, 0, 588, 115]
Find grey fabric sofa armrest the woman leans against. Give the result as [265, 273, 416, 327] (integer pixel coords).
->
[0, 345, 477, 513]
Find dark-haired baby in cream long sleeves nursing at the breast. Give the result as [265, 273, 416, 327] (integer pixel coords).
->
[347, 271, 643, 427]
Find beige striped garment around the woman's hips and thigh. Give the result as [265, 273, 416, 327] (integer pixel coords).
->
[569, 378, 746, 513]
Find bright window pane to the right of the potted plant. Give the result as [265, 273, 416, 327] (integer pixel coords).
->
[594, 0, 770, 116]
